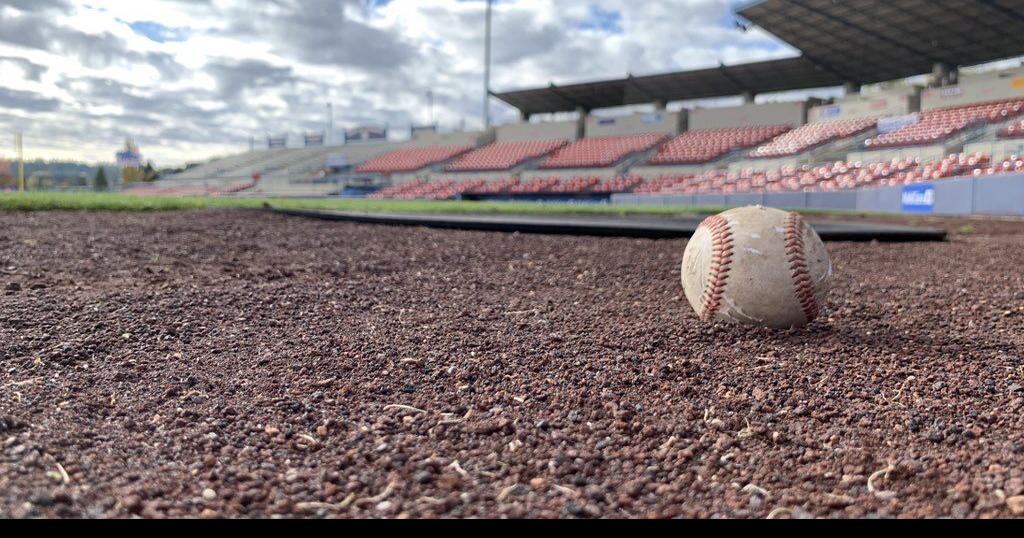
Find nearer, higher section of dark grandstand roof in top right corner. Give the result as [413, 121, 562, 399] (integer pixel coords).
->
[737, 0, 1024, 84]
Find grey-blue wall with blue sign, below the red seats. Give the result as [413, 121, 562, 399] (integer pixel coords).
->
[611, 174, 1024, 215]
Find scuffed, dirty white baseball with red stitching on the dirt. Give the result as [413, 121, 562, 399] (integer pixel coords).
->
[682, 206, 831, 329]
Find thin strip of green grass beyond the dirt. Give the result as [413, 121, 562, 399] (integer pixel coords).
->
[0, 193, 872, 215]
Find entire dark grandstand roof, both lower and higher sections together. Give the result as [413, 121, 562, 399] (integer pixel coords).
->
[494, 0, 1024, 115]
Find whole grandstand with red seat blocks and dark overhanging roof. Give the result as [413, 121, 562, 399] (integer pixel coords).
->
[146, 0, 1024, 214]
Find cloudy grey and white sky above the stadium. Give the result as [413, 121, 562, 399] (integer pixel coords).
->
[0, 0, 796, 166]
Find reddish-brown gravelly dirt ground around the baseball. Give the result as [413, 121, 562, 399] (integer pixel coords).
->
[0, 210, 1024, 518]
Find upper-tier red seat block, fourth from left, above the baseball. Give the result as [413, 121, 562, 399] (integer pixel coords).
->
[648, 125, 788, 165]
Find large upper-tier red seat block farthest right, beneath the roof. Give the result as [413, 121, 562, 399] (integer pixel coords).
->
[864, 99, 1024, 149]
